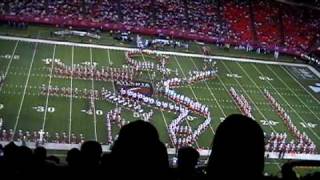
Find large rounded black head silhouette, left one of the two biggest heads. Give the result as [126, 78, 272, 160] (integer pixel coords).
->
[111, 120, 169, 178]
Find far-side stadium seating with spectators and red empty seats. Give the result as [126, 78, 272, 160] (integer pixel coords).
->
[0, 0, 320, 52]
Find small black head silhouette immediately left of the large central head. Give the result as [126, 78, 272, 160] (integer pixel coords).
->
[80, 141, 102, 167]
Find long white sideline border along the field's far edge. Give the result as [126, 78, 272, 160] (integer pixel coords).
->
[0, 35, 320, 72]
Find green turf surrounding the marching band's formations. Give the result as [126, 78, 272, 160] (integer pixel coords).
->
[0, 37, 320, 147]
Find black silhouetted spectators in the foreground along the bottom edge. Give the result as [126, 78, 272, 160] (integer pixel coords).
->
[0, 114, 320, 180]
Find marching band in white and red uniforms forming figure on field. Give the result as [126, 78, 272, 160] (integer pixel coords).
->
[0, 51, 316, 154]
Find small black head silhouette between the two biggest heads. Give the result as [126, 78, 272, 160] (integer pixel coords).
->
[178, 147, 200, 170]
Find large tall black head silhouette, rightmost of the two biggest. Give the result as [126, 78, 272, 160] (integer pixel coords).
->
[207, 114, 264, 179]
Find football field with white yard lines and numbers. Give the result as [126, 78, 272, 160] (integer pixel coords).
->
[0, 39, 320, 153]
